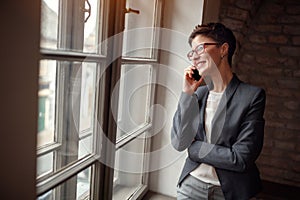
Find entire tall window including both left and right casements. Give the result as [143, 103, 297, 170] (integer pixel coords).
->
[37, 0, 162, 200]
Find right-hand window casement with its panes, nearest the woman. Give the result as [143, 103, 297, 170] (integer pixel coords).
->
[113, 0, 162, 200]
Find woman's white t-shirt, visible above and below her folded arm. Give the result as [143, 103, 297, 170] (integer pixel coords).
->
[190, 91, 223, 186]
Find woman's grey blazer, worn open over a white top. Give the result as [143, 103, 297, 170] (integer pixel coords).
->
[171, 75, 266, 200]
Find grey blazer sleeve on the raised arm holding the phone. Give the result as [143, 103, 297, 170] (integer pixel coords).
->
[171, 92, 200, 151]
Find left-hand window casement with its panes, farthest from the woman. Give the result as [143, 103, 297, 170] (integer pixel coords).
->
[37, 0, 108, 199]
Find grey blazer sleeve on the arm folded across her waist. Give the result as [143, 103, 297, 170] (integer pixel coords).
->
[188, 89, 266, 172]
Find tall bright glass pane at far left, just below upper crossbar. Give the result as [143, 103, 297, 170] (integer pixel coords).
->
[38, 60, 56, 147]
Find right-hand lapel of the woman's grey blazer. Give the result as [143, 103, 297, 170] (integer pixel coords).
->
[211, 74, 240, 144]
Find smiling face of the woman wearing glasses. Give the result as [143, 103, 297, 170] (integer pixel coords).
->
[192, 35, 221, 76]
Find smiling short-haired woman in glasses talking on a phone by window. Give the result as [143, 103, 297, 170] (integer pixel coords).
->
[171, 23, 265, 200]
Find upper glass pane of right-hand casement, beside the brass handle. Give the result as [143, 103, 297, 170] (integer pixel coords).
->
[123, 0, 157, 58]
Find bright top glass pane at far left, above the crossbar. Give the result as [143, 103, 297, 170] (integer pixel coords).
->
[41, 0, 59, 49]
